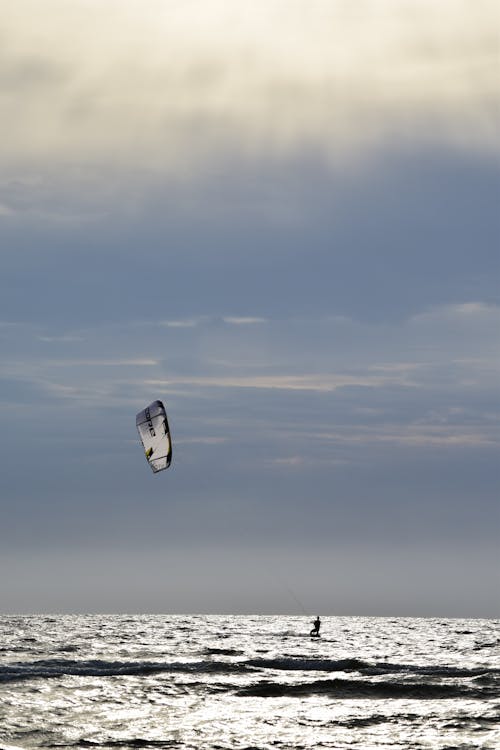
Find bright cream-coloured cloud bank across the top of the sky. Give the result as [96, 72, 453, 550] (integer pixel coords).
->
[0, 0, 498, 198]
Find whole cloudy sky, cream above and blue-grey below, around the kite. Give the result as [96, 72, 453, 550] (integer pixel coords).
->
[0, 0, 500, 617]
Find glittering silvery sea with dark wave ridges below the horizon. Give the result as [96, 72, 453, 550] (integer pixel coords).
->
[0, 613, 500, 750]
